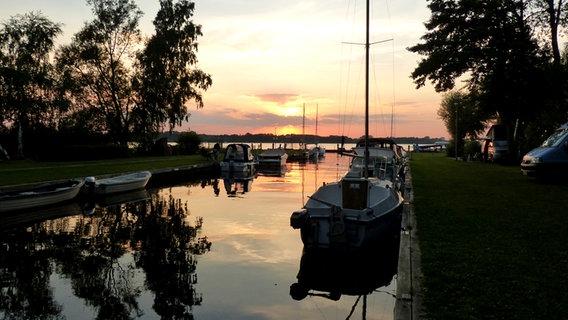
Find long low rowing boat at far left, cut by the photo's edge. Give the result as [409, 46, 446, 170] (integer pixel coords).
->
[0, 179, 84, 212]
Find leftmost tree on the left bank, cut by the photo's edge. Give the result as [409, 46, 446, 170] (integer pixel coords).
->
[0, 12, 61, 158]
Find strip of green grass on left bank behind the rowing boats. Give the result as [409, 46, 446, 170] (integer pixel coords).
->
[0, 155, 213, 186]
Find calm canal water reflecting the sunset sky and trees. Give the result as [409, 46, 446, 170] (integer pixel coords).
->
[0, 153, 398, 319]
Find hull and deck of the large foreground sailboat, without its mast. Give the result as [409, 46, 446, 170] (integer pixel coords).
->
[290, 180, 403, 248]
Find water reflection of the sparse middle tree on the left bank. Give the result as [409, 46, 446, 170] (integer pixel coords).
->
[56, 202, 145, 319]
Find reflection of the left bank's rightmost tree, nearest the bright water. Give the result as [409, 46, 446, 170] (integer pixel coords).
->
[136, 196, 211, 319]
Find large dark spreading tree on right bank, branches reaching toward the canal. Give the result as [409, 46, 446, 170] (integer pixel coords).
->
[409, 0, 548, 158]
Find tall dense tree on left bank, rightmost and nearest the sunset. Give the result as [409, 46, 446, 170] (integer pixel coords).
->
[136, 0, 212, 152]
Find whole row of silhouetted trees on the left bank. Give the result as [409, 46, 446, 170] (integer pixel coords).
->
[0, 0, 212, 158]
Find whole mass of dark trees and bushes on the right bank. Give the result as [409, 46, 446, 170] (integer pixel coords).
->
[408, 0, 568, 160]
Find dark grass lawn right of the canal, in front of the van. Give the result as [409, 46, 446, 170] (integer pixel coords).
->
[410, 154, 568, 319]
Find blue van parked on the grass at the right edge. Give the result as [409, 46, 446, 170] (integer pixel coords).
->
[521, 122, 568, 177]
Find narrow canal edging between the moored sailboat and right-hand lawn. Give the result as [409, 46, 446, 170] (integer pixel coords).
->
[394, 168, 423, 320]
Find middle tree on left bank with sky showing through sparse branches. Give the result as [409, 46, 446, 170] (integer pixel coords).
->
[58, 0, 142, 145]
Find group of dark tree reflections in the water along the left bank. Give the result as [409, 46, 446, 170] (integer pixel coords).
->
[0, 186, 211, 319]
